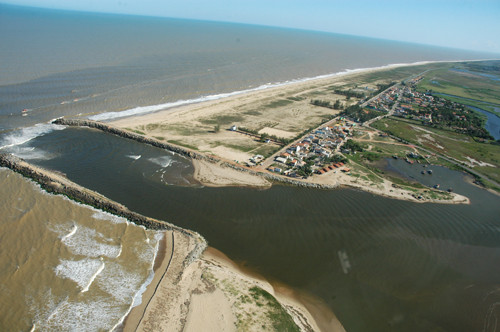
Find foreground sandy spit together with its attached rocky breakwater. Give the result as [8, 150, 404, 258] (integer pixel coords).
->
[0, 154, 344, 331]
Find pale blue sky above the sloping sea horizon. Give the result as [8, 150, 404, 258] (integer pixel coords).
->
[0, 0, 500, 53]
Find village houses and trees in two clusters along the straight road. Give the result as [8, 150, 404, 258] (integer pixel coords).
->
[236, 75, 490, 179]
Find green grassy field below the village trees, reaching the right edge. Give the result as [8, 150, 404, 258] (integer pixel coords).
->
[372, 118, 500, 182]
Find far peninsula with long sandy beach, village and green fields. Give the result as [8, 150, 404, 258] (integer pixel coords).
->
[102, 63, 498, 203]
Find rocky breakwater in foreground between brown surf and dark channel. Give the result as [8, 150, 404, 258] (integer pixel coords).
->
[0, 153, 207, 248]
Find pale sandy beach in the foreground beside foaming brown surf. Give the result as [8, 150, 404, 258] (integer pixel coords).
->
[123, 231, 344, 331]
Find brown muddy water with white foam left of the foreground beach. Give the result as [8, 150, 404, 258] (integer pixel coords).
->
[0, 168, 162, 331]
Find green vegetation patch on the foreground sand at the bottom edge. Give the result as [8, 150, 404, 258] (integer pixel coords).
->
[250, 286, 300, 332]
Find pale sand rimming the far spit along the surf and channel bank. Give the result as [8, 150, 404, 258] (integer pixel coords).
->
[103, 61, 470, 204]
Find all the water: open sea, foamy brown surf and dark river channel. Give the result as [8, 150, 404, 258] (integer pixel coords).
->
[0, 4, 500, 331]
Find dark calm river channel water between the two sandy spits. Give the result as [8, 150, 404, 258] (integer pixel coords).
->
[11, 128, 500, 331]
